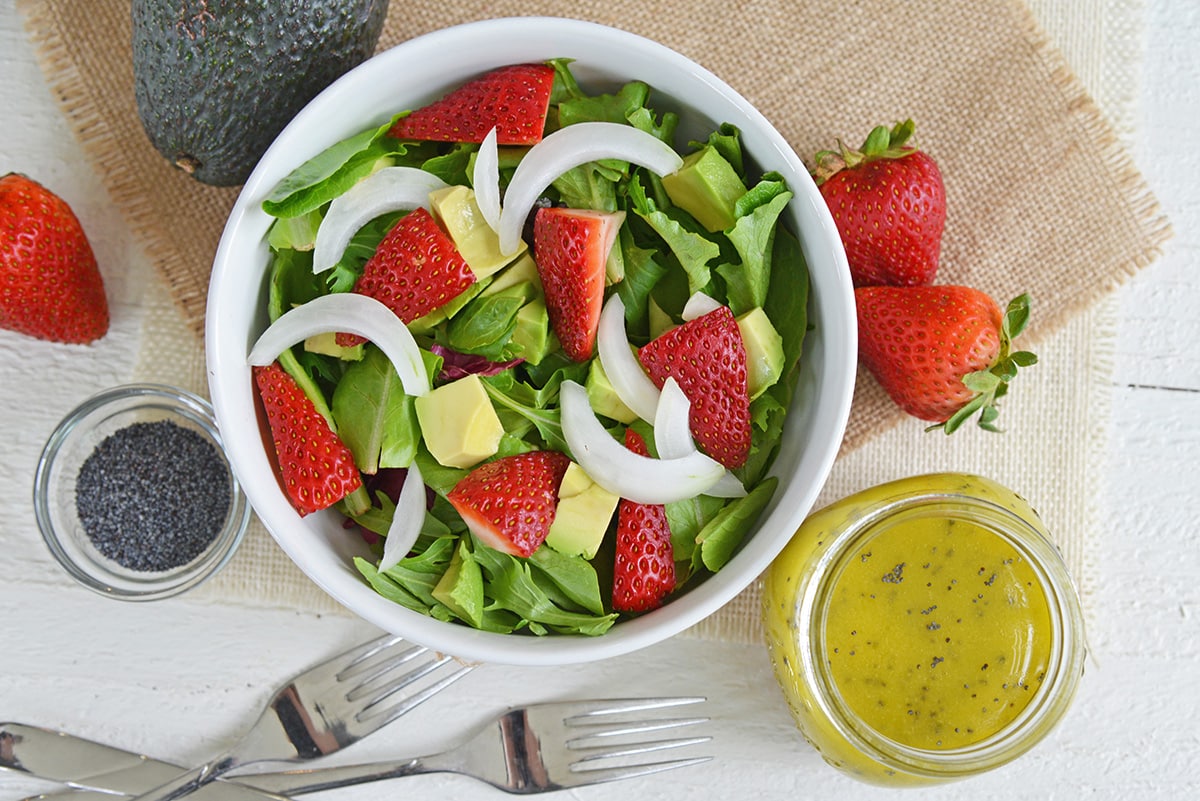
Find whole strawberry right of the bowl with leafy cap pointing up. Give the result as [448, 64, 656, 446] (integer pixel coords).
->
[812, 120, 946, 287]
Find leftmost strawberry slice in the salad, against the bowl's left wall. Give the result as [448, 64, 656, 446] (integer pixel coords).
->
[254, 362, 362, 516]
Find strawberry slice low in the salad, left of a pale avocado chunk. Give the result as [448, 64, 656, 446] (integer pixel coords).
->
[446, 451, 570, 556]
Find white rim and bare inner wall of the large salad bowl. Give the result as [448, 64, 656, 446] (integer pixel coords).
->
[205, 17, 857, 666]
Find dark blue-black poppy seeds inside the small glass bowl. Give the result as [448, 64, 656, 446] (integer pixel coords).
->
[76, 420, 232, 572]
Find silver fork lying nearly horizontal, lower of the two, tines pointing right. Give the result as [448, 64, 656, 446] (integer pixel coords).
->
[234, 698, 712, 795]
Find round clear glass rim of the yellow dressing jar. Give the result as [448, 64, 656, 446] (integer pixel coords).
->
[797, 492, 1085, 777]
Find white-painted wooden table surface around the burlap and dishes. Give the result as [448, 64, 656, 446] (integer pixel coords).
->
[0, 0, 1200, 801]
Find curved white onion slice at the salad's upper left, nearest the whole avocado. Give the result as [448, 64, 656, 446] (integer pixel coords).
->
[312, 167, 446, 272]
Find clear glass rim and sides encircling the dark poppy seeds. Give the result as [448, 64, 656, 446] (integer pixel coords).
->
[32, 383, 251, 601]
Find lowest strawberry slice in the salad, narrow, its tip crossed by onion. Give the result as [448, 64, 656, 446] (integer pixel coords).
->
[612, 429, 676, 612]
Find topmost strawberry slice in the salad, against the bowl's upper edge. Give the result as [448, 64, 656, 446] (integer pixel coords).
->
[388, 64, 554, 145]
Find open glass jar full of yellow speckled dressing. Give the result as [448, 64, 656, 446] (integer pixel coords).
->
[763, 474, 1086, 785]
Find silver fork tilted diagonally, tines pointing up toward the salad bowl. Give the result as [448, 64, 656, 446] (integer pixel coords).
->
[118, 634, 472, 801]
